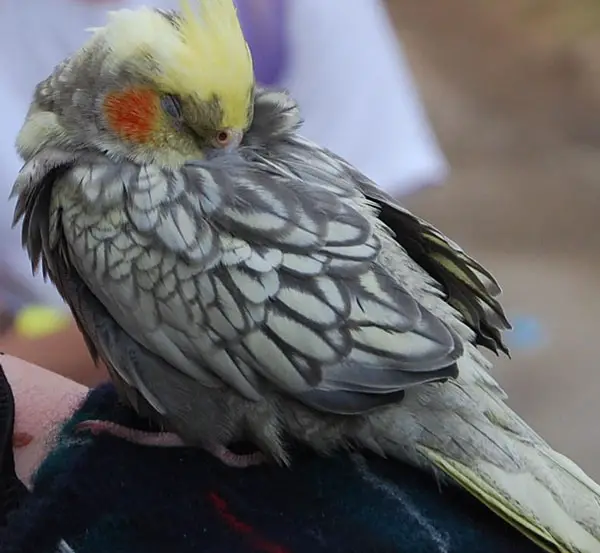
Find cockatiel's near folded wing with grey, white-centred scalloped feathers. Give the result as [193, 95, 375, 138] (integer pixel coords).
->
[54, 148, 462, 411]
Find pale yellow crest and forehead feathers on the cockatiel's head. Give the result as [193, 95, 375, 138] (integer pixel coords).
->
[99, 0, 254, 129]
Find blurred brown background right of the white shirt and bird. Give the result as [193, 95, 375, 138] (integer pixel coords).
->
[388, 0, 600, 479]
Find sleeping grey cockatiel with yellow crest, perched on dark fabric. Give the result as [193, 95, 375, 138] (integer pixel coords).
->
[8, 0, 600, 553]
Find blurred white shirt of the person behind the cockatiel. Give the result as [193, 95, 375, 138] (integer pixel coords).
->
[0, 0, 446, 305]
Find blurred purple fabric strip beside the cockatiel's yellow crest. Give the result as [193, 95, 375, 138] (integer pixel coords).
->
[235, 0, 289, 86]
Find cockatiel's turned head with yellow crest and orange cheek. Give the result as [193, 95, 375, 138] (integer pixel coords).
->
[17, 0, 254, 167]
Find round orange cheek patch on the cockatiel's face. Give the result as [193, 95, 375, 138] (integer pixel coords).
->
[104, 88, 160, 143]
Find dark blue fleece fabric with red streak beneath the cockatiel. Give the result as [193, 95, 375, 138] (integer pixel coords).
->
[0, 386, 540, 553]
